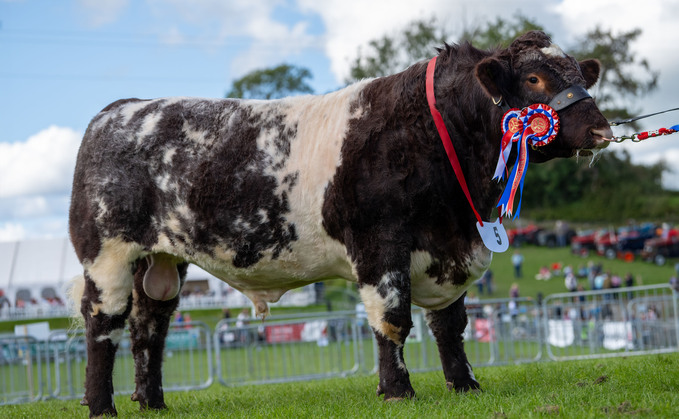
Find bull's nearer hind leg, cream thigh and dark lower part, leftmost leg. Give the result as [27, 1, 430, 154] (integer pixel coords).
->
[80, 240, 137, 416]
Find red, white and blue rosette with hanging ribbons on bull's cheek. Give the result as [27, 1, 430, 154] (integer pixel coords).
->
[493, 103, 559, 218]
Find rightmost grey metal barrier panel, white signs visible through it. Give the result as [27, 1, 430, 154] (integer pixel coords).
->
[543, 285, 679, 360]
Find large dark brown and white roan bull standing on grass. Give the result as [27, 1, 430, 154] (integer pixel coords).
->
[70, 32, 611, 416]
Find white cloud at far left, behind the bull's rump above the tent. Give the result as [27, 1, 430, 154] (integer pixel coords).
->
[0, 126, 82, 198]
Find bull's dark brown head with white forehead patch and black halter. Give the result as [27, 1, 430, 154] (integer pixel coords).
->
[476, 31, 613, 162]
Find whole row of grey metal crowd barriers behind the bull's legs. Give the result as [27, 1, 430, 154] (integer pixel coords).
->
[0, 285, 679, 405]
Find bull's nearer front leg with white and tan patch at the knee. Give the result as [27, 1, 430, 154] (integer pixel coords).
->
[359, 269, 415, 400]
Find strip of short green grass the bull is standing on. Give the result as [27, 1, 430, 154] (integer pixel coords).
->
[0, 353, 679, 418]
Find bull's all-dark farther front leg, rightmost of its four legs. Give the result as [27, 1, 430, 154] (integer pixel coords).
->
[426, 296, 481, 391]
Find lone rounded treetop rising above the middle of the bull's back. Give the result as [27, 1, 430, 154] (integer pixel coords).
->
[226, 64, 314, 99]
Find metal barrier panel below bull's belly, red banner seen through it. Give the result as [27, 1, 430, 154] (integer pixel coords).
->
[214, 313, 363, 385]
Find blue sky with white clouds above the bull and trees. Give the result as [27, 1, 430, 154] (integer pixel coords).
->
[0, 0, 679, 242]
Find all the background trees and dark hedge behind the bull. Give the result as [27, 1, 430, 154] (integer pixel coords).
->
[227, 15, 679, 222]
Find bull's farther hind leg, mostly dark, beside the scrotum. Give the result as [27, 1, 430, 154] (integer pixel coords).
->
[130, 255, 188, 410]
